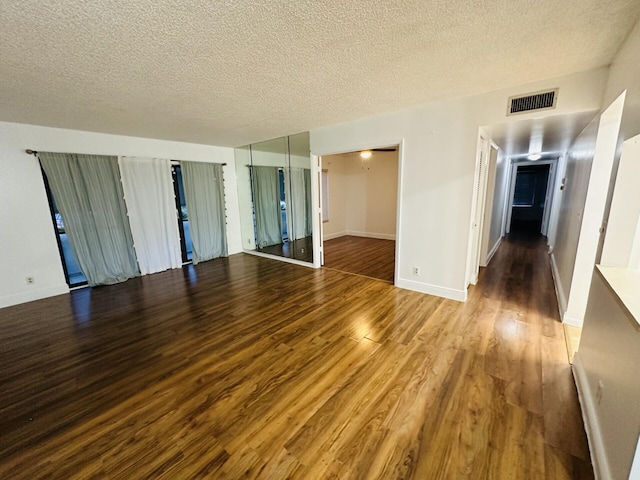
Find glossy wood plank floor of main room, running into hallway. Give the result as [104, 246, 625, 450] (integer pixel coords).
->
[0, 235, 593, 480]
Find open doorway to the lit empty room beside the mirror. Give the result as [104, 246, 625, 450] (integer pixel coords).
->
[319, 146, 399, 283]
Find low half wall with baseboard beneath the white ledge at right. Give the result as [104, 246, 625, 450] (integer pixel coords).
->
[574, 272, 640, 479]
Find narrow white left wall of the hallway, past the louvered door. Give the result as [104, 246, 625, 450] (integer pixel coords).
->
[480, 147, 509, 267]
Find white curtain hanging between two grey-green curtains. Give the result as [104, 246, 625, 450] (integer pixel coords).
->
[118, 157, 182, 274]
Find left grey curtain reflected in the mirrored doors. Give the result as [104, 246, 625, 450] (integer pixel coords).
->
[251, 167, 282, 248]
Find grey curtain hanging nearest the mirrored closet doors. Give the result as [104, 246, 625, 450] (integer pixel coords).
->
[180, 162, 227, 265]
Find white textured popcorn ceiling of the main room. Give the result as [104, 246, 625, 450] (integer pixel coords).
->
[0, 0, 640, 146]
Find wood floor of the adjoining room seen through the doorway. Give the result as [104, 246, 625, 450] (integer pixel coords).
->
[323, 235, 396, 283]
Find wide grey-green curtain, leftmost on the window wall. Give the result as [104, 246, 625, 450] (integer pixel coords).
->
[38, 152, 140, 286]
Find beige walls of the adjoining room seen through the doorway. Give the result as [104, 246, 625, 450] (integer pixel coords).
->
[322, 152, 398, 240]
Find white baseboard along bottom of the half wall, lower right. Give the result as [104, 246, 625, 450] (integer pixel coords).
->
[572, 351, 612, 479]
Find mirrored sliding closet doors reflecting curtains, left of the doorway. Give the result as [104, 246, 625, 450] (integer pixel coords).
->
[235, 132, 313, 262]
